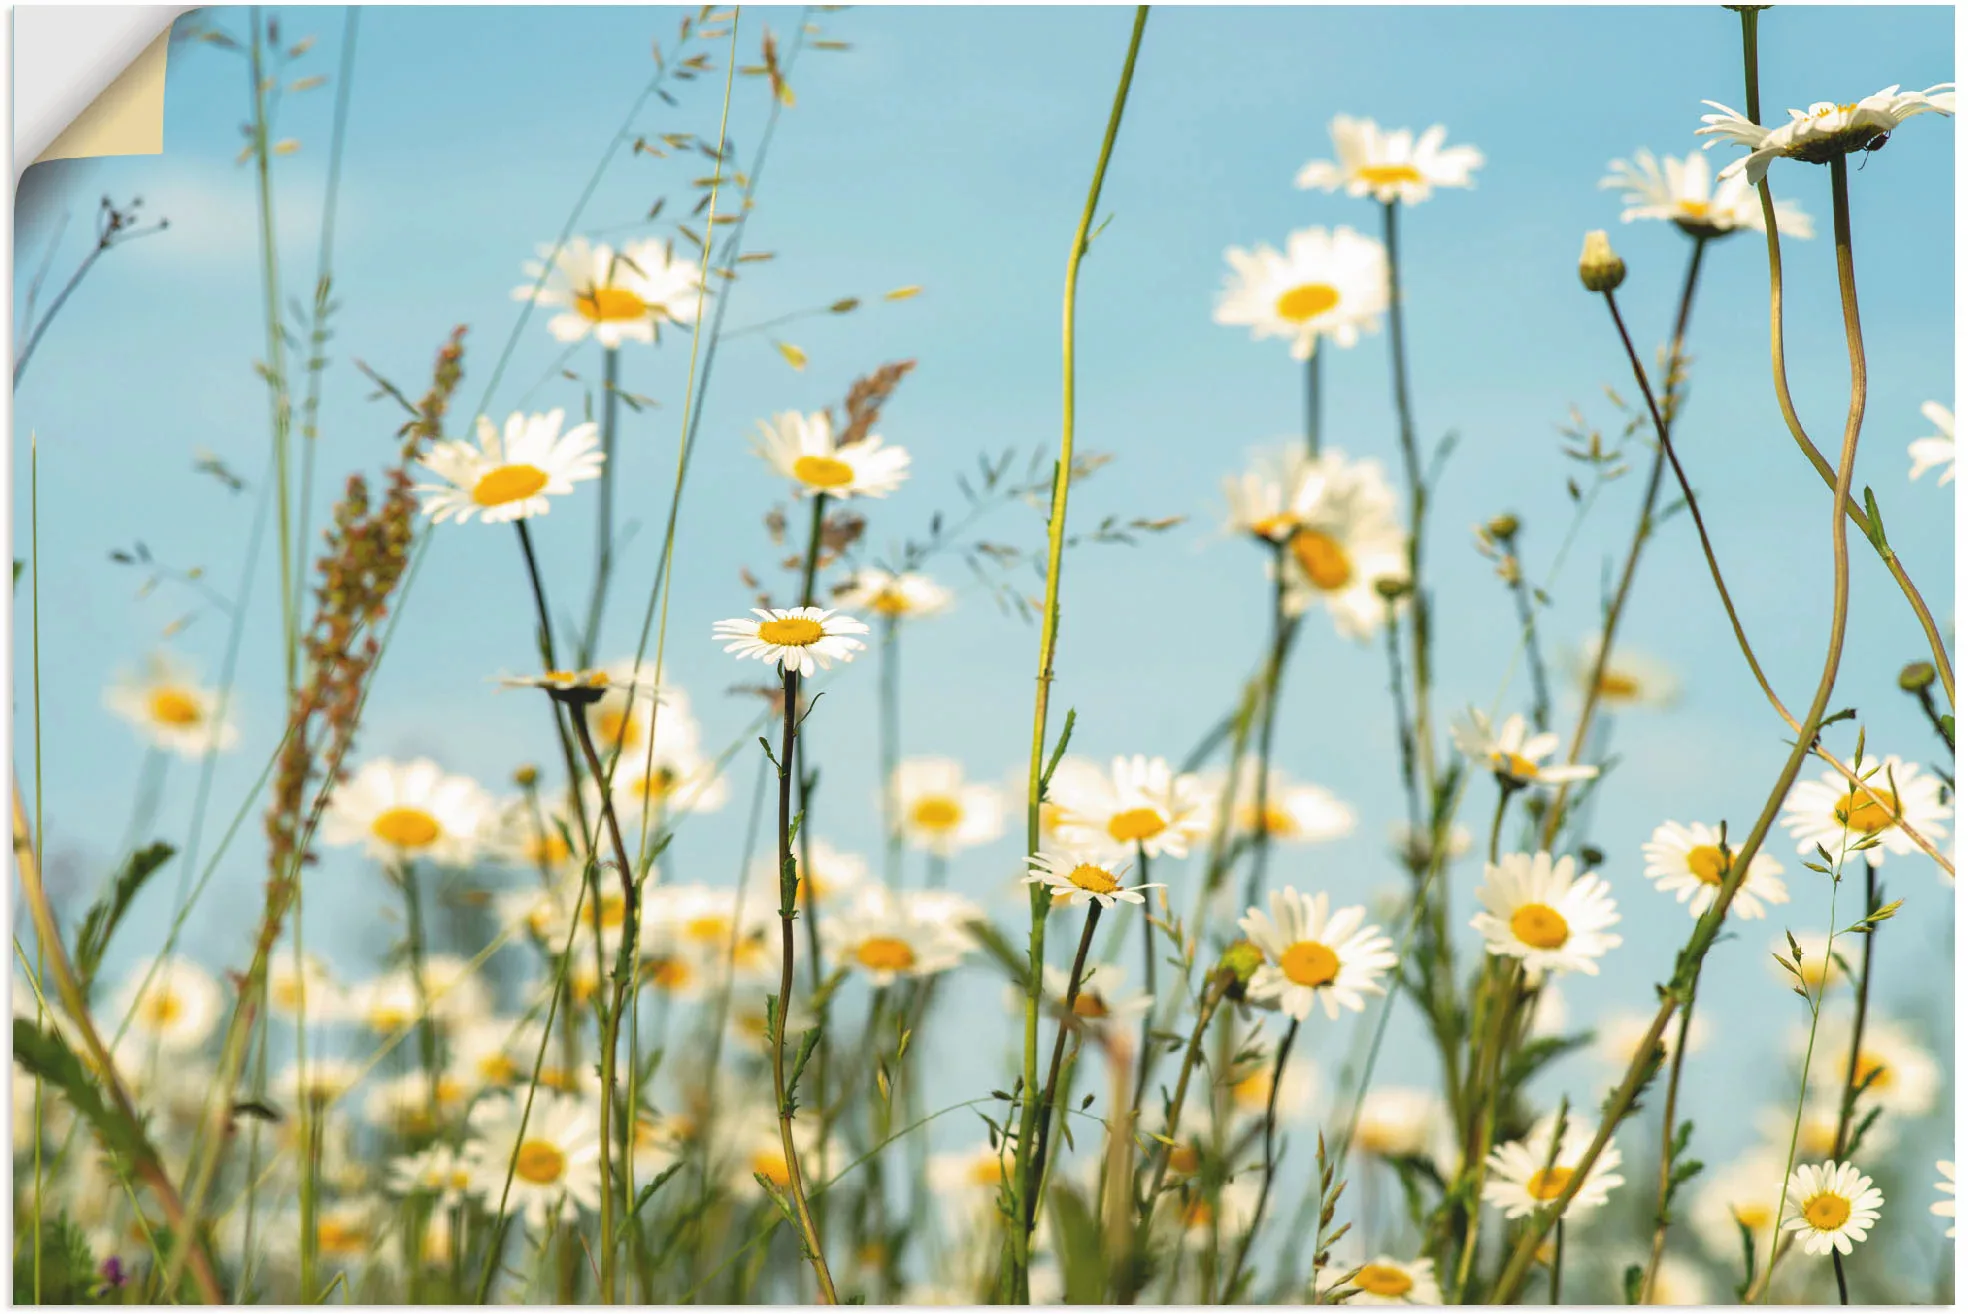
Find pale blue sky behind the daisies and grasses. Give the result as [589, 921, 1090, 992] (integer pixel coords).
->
[14, 6, 1954, 1274]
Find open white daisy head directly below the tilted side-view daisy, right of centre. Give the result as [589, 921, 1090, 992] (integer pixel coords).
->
[1470, 852, 1620, 980]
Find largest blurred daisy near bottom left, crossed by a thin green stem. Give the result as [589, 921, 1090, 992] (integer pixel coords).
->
[464, 1094, 602, 1231]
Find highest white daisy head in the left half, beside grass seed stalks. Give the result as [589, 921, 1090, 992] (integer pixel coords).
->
[512, 238, 705, 350]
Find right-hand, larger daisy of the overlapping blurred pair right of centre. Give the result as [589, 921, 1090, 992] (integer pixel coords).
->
[1279, 450, 1407, 639]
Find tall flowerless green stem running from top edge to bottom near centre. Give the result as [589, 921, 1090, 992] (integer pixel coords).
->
[1000, 4, 1147, 1300]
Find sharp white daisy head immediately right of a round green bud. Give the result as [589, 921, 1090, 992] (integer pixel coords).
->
[1238, 887, 1395, 1021]
